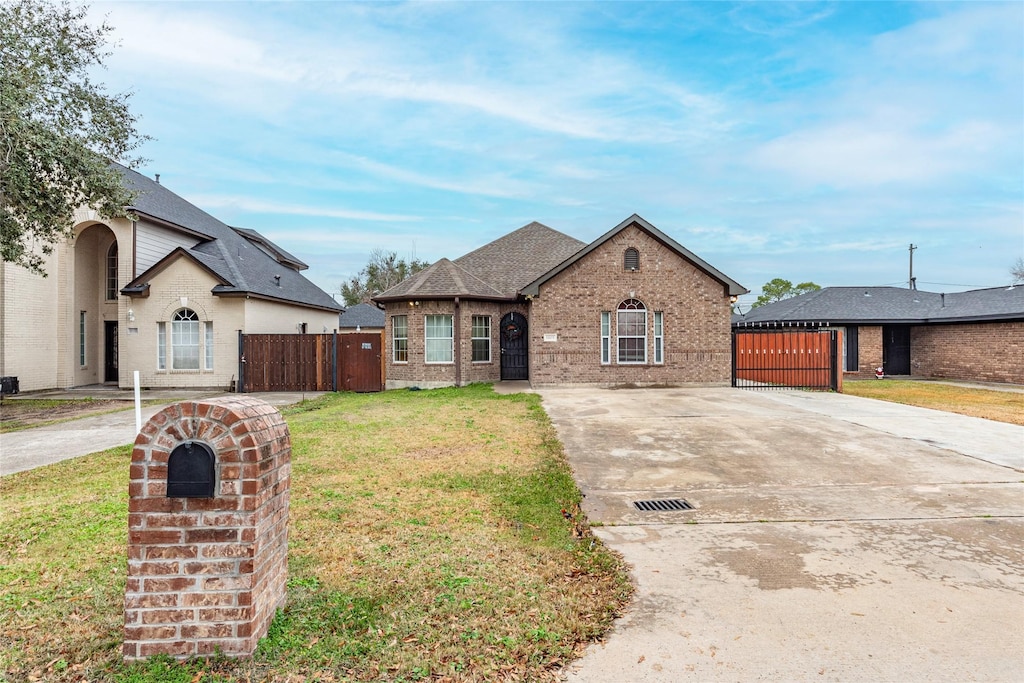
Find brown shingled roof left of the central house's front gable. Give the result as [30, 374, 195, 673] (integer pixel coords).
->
[374, 222, 586, 301]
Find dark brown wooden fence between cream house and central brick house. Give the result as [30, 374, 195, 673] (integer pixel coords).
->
[238, 333, 384, 393]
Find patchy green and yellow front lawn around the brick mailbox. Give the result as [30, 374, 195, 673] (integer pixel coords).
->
[0, 386, 632, 683]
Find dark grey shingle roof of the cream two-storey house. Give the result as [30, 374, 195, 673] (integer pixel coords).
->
[115, 164, 341, 310]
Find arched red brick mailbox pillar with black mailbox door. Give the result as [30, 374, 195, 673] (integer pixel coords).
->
[123, 396, 292, 660]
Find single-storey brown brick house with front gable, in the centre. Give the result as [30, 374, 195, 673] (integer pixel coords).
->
[374, 214, 748, 388]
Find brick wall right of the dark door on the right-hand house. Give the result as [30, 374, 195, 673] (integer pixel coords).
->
[910, 323, 1024, 384]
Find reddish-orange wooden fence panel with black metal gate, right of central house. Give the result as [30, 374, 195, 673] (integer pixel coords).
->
[732, 330, 843, 391]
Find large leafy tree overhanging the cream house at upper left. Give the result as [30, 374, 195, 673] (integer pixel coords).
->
[0, 0, 147, 275]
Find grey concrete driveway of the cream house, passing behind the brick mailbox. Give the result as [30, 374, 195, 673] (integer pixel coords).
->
[0, 389, 323, 476]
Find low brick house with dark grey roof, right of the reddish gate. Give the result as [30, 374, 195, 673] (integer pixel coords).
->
[733, 286, 1024, 384]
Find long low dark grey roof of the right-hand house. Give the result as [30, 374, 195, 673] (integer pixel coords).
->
[733, 287, 1024, 326]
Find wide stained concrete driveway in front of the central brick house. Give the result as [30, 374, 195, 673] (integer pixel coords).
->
[540, 388, 1024, 683]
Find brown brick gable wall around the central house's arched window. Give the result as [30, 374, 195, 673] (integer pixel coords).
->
[529, 226, 731, 385]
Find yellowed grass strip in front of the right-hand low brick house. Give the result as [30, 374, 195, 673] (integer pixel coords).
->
[843, 380, 1024, 425]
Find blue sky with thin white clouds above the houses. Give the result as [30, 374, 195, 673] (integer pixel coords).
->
[92, 2, 1024, 304]
